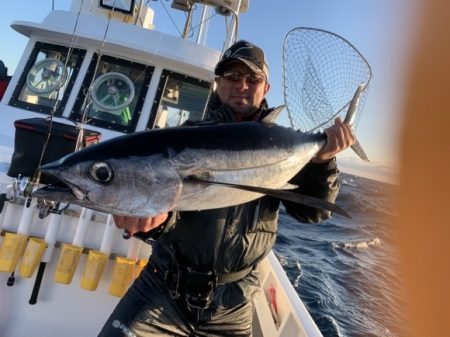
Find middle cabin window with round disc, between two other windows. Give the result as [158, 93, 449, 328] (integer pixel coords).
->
[70, 55, 154, 132]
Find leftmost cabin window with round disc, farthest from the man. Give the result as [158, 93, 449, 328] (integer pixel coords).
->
[10, 42, 86, 116]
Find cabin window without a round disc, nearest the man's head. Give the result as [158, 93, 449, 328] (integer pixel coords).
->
[147, 70, 211, 129]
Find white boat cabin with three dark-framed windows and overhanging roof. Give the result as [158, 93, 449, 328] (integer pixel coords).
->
[0, 0, 247, 139]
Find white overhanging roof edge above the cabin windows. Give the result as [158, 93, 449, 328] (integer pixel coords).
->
[11, 11, 220, 80]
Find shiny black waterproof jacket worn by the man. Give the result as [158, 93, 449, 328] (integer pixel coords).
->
[144, 94, 339, 305]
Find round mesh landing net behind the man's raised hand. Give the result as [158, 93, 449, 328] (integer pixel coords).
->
[283, 27, 372, 132]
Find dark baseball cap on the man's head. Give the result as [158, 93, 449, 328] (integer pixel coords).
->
[214, 40, 269, 80]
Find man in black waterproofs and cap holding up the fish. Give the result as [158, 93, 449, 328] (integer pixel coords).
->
[100, 41, 355, 337]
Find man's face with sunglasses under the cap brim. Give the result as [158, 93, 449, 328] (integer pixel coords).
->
[217, 62, 270, 116]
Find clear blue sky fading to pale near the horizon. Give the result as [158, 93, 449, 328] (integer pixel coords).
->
[0, 0, 419, 182]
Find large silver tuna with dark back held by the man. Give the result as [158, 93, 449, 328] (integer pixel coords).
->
[33, 87, 370, 217]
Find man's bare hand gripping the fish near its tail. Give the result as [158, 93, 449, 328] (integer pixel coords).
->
[312, 117, 356, 163]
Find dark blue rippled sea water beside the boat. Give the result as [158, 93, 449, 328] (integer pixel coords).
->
[274, 173, 407, 337]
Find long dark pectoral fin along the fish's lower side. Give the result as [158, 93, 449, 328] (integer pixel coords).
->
[186, 176, 351, 218]
